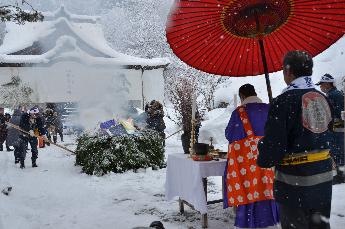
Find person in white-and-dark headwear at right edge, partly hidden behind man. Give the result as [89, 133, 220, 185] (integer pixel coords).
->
[316, 74, 345, 184]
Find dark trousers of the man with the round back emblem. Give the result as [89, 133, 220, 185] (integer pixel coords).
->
[279, 204, 331, 229]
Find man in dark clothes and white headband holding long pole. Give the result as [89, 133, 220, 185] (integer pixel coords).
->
[19, 107, 48, 169]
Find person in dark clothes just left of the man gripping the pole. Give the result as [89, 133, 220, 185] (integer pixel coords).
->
[6, 109, 22, 164]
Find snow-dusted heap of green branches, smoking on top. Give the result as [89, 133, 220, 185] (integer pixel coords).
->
[75, 130, 164, 176]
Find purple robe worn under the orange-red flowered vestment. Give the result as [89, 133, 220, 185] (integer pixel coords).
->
[224, 103, 279, 228]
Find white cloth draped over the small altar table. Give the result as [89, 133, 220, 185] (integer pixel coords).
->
[165, 153, 226, 214]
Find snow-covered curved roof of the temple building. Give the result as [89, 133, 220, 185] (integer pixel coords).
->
[0, 7, 169, 68]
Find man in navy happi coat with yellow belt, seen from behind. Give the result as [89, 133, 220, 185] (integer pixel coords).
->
[257, 51, 333, 229]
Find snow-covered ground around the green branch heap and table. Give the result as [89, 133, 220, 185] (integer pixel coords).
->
[0, 109, 345, 229]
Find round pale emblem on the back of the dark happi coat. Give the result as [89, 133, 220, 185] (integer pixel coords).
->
[302, 92, 332, 133]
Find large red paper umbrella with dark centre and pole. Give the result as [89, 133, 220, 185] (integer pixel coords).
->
[166, 0, 345, 100]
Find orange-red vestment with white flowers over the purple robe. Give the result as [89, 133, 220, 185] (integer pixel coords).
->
[226, 107, 274, 206]
